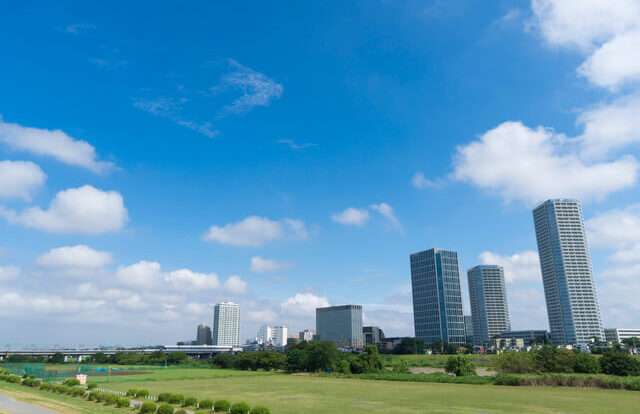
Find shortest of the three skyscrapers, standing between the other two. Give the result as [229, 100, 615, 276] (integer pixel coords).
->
[467, 265, 511, 346]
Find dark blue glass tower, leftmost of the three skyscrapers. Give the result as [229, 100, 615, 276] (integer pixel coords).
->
[410, 249, 466, 345]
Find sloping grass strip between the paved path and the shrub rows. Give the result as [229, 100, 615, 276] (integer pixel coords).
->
[0, 381, 123, 414]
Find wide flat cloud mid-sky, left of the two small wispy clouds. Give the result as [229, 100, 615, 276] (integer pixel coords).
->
[202, 216, 308, 247]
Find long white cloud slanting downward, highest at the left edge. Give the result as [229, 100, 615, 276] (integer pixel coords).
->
[0, 118, 113, 172]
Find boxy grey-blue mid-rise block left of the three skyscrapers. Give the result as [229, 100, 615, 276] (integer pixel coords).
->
[316, 305, 363, 349]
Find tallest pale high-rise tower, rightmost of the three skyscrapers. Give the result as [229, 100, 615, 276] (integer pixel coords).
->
[533, 199, 604, 344]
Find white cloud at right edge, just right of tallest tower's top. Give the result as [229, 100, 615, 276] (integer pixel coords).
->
[585, 204, 640, 248]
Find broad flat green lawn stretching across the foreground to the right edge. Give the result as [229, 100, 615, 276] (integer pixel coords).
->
[102, 374, 640, 414]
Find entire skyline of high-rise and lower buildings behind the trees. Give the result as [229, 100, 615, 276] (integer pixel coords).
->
[180, 199, 640, 353]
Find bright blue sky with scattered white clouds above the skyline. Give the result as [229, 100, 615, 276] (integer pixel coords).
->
[0, 0, 640, 346]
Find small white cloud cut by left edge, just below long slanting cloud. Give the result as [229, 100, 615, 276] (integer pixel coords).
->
[0, 160, 47, 201]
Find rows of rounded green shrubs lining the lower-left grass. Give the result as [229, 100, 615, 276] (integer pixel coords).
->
[0, 372, 270, 414]
